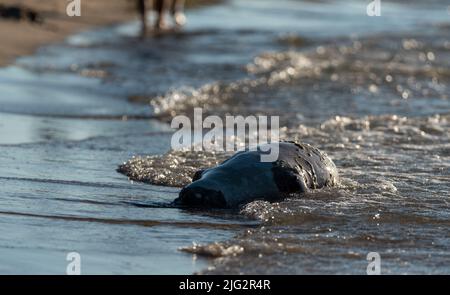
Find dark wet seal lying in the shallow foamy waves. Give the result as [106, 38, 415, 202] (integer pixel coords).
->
[173, 142, 339, 208]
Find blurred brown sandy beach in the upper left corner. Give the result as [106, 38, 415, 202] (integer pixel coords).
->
[0, 0, 220, 67]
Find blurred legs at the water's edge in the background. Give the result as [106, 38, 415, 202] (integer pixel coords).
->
[137, 0, 186, 36]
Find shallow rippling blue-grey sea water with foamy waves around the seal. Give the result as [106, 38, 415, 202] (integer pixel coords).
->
[0, 0, 450, 274]
